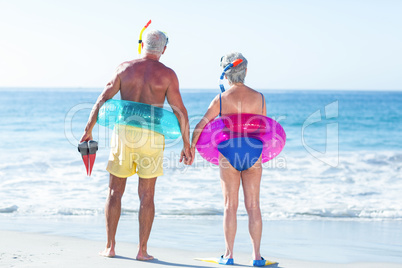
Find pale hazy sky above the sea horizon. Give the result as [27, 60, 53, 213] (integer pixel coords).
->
[0, 0, 402, 90]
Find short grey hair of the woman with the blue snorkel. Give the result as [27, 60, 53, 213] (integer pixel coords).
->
[221, 52, 247, 83]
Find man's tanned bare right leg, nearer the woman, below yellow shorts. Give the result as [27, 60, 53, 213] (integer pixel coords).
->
[137, 178, 156, 261]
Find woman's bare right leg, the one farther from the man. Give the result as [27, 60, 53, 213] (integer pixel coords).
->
[241, 158, 262, 260]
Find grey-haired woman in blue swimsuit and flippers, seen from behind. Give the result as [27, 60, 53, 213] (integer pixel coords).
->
[191, 53, 276, 266]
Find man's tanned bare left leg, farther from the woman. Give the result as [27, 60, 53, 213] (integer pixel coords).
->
[99, 174, 127, 257]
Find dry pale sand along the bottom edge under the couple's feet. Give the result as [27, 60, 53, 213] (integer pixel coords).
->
[0, 231, 402, 268]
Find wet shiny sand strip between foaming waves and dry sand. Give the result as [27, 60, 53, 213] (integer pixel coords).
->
[0, 214, 402, 267]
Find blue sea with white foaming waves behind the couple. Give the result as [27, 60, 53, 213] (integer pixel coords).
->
[0, 89, 402, 262]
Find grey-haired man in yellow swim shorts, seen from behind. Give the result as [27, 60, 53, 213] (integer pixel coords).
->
[81, 30, 192, 260]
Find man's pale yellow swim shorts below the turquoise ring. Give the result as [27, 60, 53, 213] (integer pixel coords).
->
[106, 125, 165, 179]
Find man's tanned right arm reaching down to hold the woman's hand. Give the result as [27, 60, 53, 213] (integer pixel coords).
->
[166, 70, 192, 164]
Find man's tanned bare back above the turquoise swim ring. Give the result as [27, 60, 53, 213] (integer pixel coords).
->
[117, 58, 177, 107]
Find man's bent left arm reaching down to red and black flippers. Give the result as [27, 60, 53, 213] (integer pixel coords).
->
[80, 73, 120, 142]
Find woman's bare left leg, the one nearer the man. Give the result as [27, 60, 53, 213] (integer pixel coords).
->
[219, 154, 240, 258]
